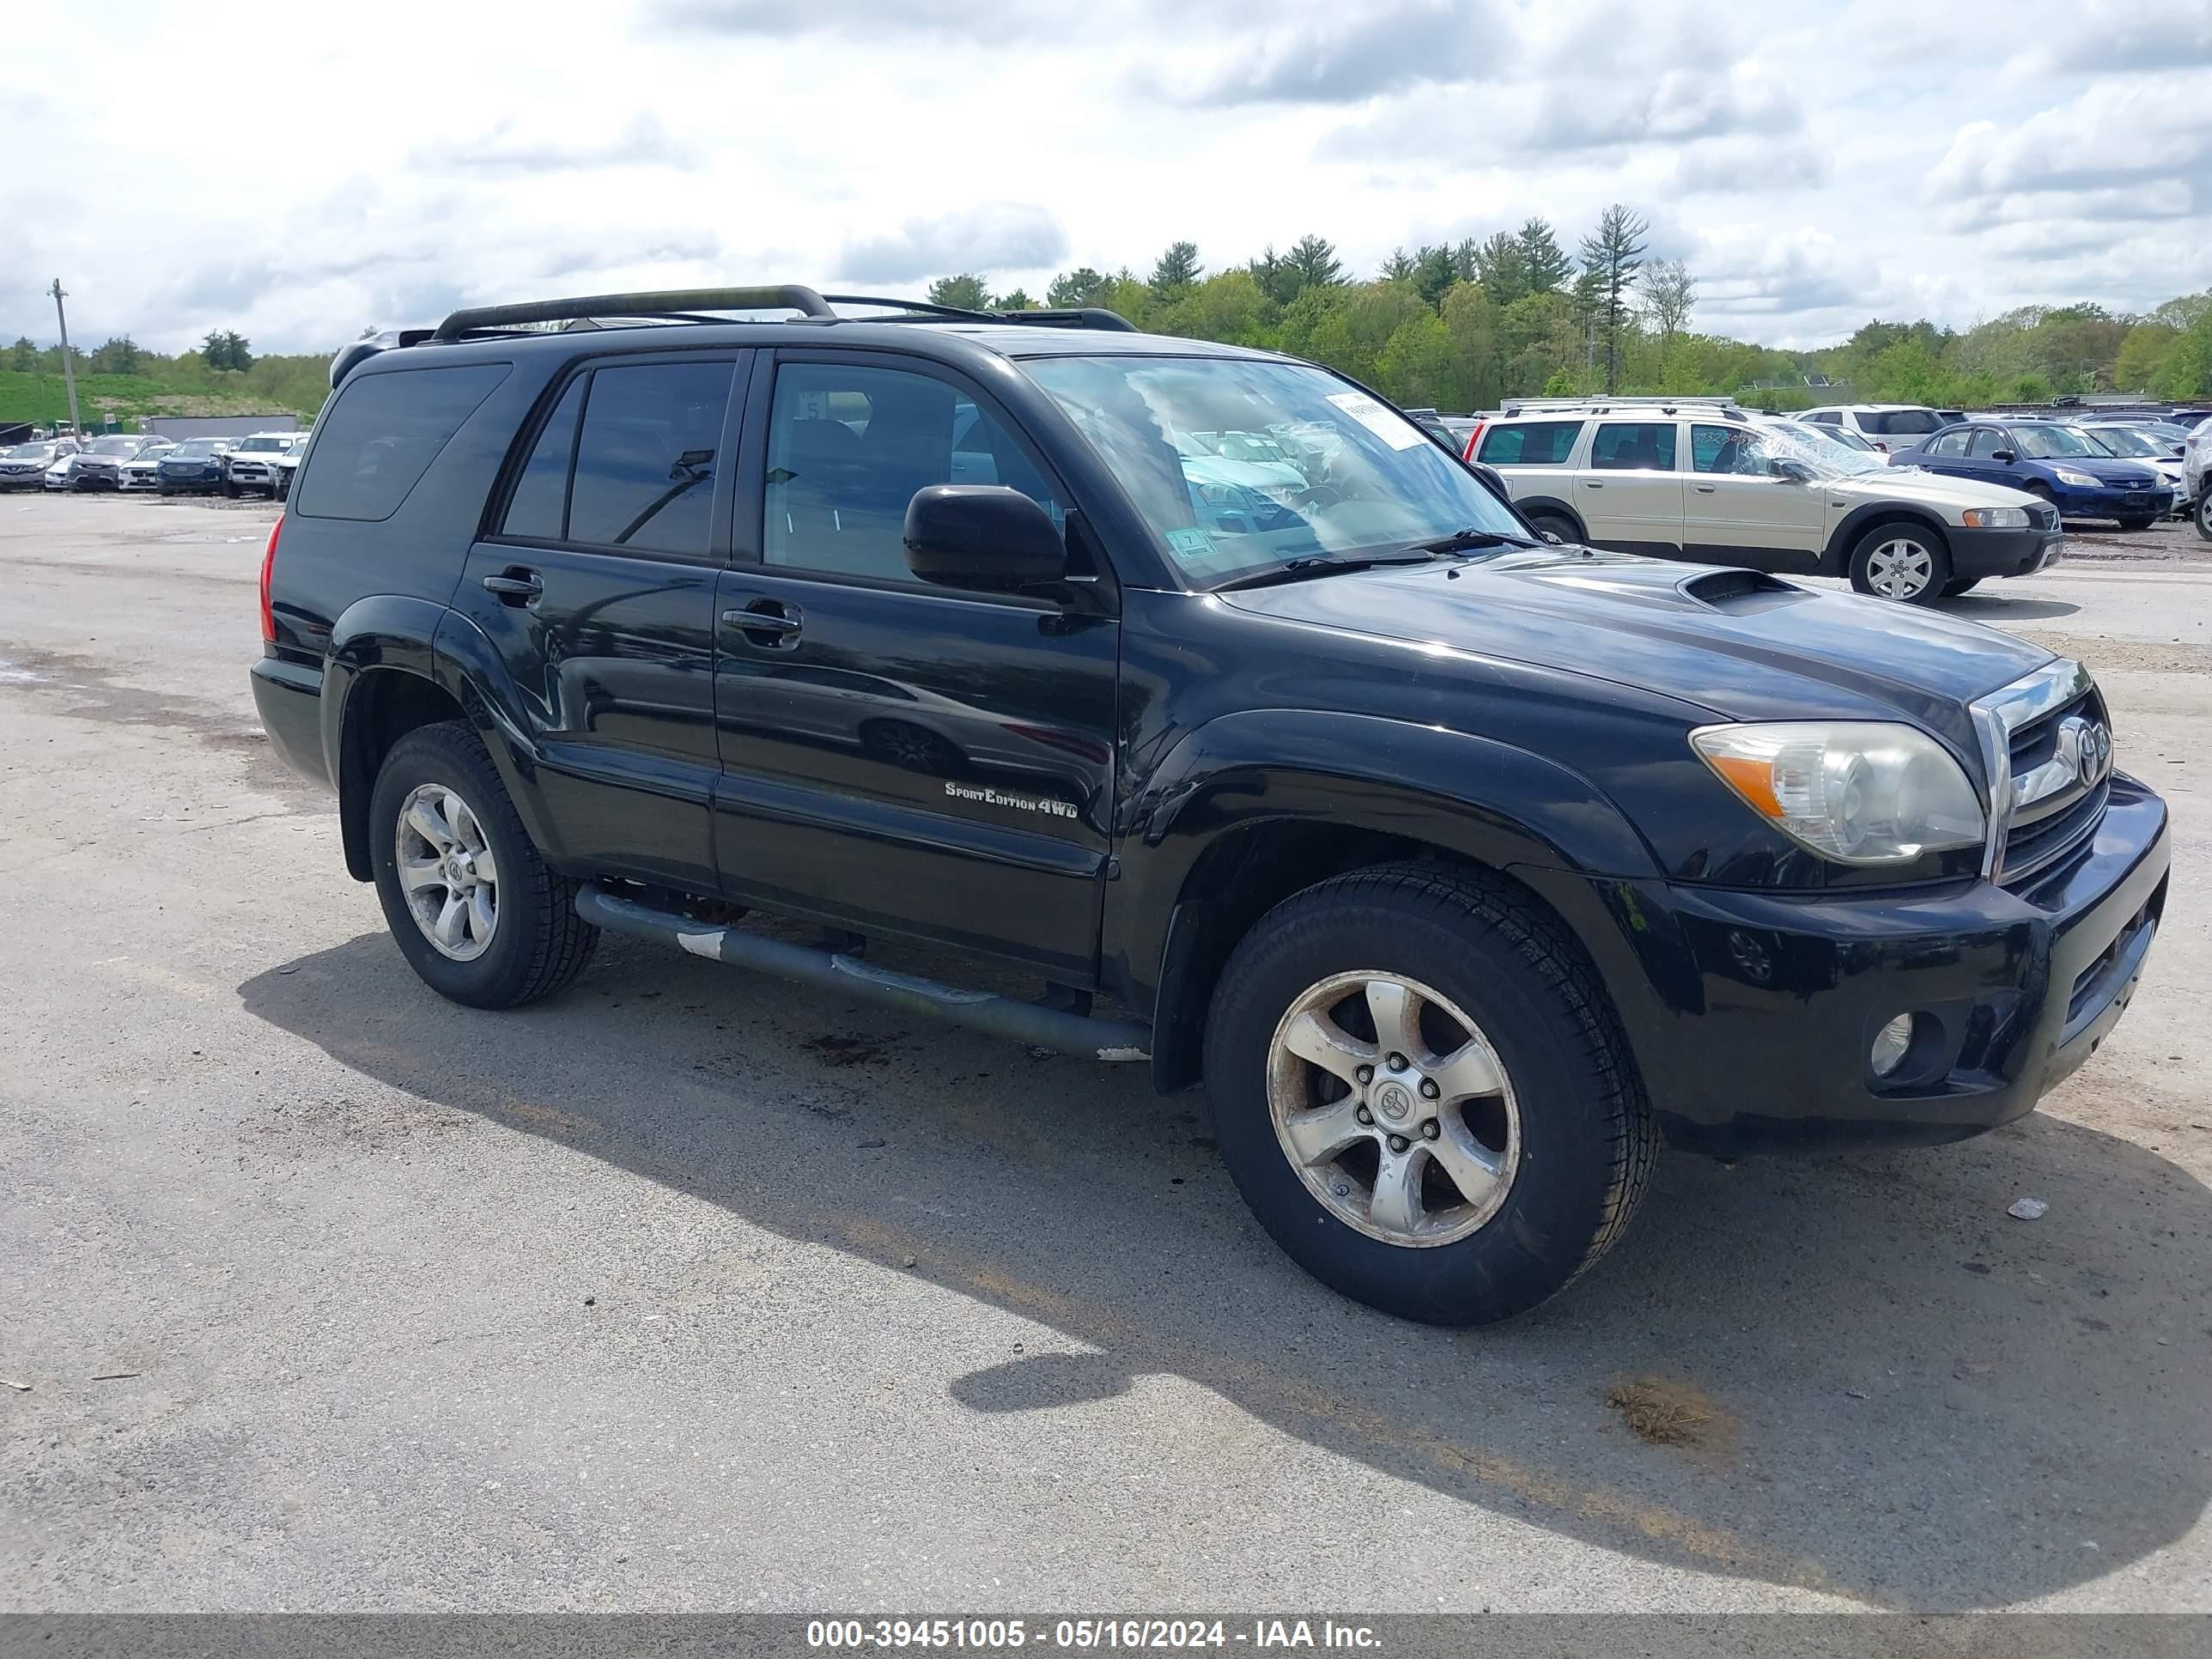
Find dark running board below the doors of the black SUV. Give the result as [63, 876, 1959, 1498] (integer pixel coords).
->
[575, 887, 1152, 1060]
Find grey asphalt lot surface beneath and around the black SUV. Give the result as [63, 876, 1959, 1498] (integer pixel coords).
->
[0, 495, 2212, 1613]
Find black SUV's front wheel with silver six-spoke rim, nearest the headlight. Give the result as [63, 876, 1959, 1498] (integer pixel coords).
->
[1206, 865, 1656, 1325]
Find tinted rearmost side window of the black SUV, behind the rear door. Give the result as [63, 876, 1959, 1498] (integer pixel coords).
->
[292, 362, 514, 520]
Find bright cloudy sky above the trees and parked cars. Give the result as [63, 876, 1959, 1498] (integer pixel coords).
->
[0, 0, 2212, 352]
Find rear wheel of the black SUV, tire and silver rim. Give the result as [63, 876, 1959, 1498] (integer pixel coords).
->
[369, 721, 599, 1009]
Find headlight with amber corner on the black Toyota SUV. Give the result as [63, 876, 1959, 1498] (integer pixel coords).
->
[1690, 721, 1989, 865]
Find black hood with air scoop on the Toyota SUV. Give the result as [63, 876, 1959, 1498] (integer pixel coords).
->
[1221, 549, 2051, 754]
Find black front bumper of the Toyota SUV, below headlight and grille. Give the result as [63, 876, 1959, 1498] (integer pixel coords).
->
[1524, 772, 2172, 1157]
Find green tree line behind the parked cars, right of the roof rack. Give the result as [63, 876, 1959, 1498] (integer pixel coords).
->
[929, 204, 2212, 410]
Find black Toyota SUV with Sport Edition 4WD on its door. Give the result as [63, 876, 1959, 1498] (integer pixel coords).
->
[252, 288, 2167, 1321]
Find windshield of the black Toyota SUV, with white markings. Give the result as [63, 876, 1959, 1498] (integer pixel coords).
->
[1022, 356, 1528, 584]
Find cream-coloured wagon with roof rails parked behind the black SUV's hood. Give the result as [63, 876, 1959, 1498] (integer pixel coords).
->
[1471, 398, 2062, 604]
